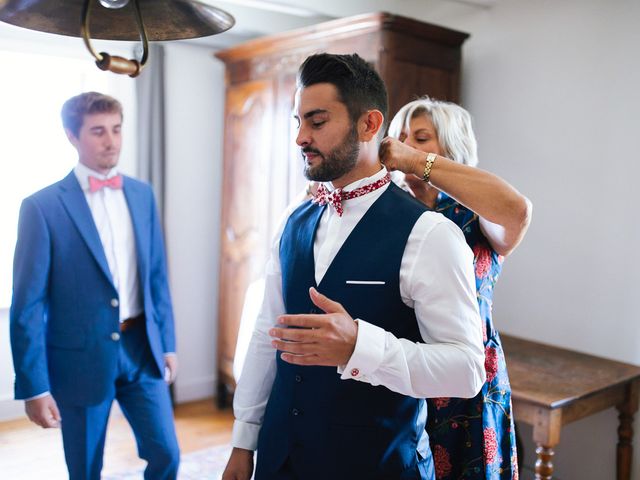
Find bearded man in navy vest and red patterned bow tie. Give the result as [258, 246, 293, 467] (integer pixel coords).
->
[223, 54, 485, 480]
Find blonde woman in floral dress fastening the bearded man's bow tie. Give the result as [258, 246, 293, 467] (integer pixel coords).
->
[380, 97, 532, 480]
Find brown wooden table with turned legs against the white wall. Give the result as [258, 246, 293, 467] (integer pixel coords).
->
[501, 335, 640, 480]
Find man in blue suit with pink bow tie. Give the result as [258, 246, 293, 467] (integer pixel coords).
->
[10, 92, 180, 480]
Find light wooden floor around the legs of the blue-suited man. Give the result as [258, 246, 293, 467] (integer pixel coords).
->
[0, 399, 233, 480]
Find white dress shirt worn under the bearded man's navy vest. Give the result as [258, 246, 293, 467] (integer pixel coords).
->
[231, 167, 485, 450]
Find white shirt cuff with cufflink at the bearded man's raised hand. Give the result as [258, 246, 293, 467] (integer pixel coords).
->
[338, 319, 387, 383]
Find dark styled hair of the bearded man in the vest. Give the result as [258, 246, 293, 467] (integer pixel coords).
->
[297, 53, 388, 131]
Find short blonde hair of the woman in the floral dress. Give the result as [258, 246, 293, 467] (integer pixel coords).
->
[389, 96, 478, 167]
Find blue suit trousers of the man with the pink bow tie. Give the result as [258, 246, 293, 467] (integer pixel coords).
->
[58, 325, 180, 480]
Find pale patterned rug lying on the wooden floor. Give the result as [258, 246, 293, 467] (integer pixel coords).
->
[102, 445, 231, 480]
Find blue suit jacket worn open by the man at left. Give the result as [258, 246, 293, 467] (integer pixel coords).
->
[10, 172, 175, 406]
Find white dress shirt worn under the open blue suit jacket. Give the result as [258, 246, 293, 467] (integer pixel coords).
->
[74, 163, 143, 321]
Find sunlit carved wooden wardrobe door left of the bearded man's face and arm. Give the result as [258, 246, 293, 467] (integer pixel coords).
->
[218, 81, 273, 393]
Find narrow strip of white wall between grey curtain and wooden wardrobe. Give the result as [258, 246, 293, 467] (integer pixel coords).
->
[165, 43, 224, 402]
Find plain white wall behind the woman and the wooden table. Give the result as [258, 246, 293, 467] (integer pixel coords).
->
[404, 0, 640, 480]
